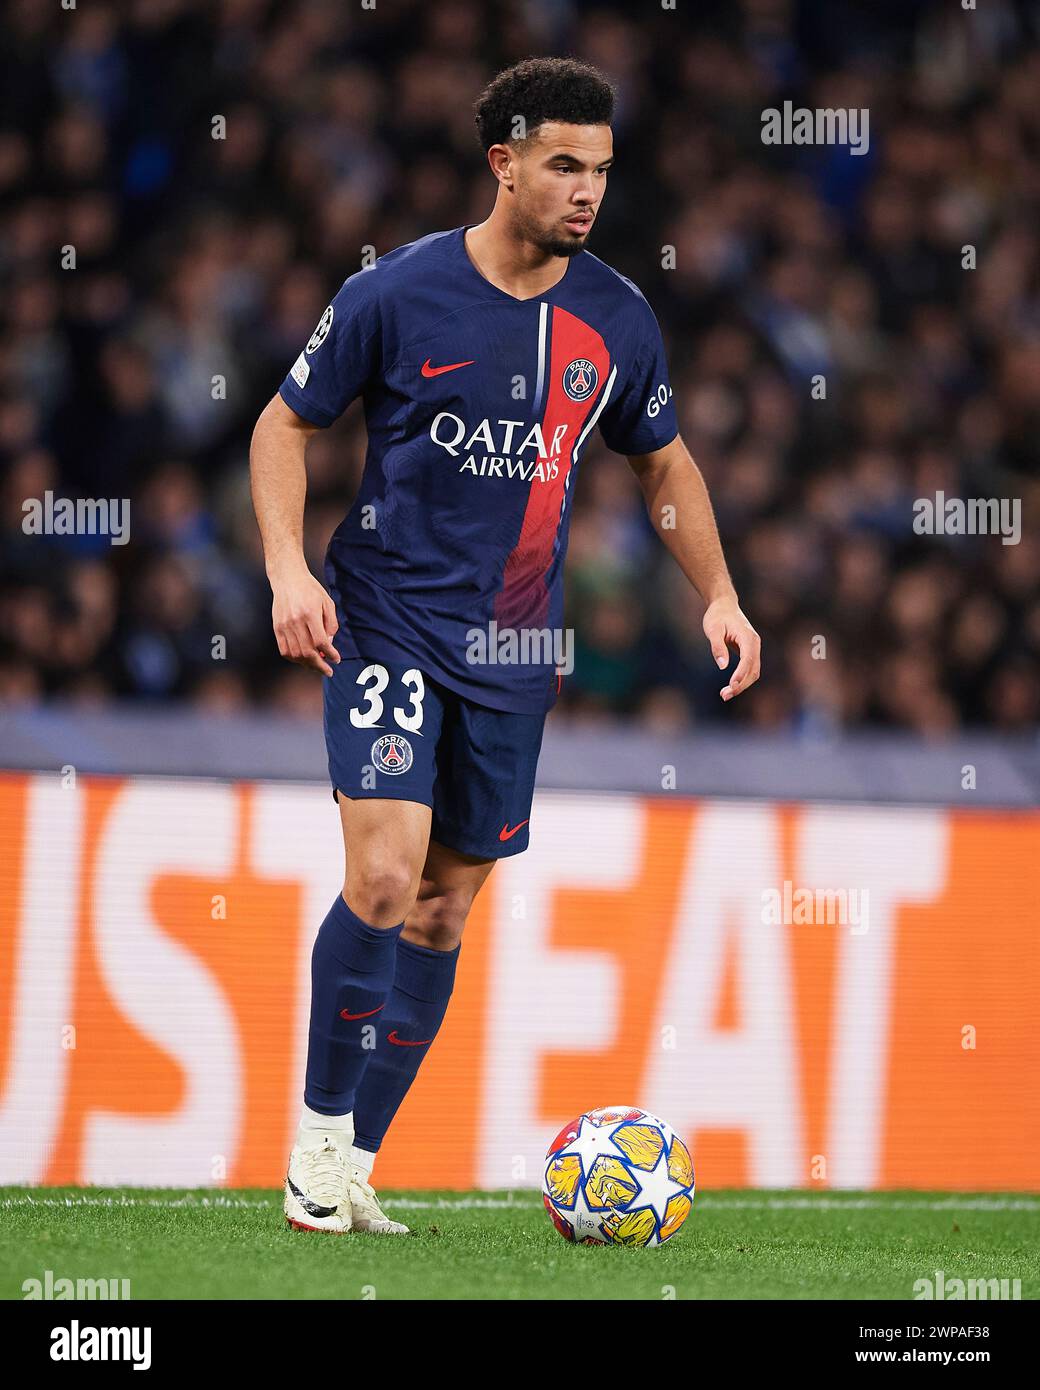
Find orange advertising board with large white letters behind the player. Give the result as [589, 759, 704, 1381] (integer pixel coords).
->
[0, 774, 1040, 1190]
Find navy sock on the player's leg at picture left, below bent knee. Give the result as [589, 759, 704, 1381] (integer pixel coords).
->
[303, 894, 405, 1115]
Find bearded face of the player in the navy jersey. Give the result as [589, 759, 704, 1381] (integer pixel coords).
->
[516, 121, 613, 256]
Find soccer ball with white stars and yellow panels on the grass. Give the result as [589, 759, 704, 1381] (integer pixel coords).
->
[542, 1105, 694, 1245]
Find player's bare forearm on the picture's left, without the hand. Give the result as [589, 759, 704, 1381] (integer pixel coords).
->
[249, 398, 309, 584]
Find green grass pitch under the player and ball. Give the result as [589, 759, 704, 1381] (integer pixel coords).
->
[0, 1187, 1040, 1307]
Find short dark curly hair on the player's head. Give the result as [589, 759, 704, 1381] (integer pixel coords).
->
[473, 58, 615, 150]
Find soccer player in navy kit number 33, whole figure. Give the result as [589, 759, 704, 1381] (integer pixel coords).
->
[250, 58, 759, 1234]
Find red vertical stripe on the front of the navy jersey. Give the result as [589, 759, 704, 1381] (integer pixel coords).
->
[495, 306, 610, 628]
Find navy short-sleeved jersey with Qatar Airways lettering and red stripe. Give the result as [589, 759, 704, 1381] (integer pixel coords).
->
[281, 227, 677, 713]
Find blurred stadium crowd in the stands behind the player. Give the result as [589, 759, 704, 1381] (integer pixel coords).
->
[0, 0, 1040, 734]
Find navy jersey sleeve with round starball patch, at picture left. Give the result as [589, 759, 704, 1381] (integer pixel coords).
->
[278, 270, 382, 428]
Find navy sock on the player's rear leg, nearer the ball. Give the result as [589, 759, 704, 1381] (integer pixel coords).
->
[355, 937, 462, 1154]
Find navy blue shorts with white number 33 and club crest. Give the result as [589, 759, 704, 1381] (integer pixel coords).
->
[323, 657, 545, 859]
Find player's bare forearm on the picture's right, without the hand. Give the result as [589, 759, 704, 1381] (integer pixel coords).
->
[640, 449, 736, 603]
